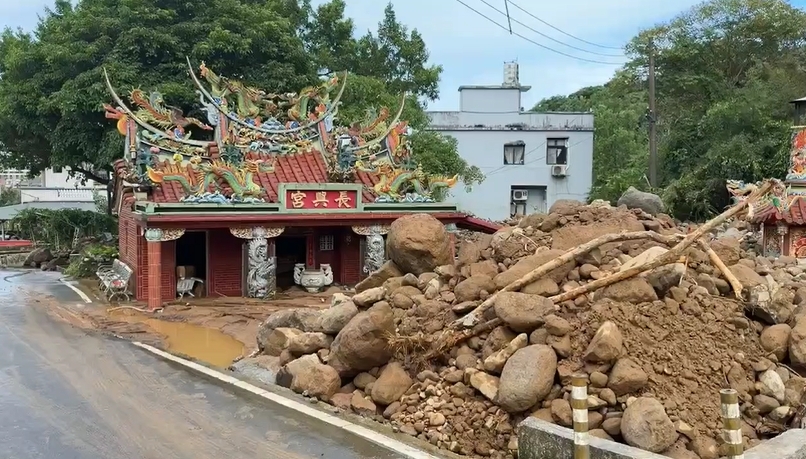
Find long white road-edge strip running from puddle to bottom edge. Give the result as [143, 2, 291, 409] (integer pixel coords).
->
[132, 341, 442, 459]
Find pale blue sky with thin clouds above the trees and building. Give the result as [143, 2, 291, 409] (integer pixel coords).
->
[0, 0, 806, 110]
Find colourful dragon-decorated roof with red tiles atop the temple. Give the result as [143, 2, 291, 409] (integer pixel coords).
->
[103, 60, 457, 203]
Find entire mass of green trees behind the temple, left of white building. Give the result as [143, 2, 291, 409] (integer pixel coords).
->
[0, 0, 479, 190]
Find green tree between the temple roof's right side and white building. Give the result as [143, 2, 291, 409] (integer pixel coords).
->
[301, 0, 484, 187]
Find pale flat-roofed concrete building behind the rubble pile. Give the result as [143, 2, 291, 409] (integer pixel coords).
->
[428, 63, 593, 221]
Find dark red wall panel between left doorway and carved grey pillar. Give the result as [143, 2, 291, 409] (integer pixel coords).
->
[207, 229, 244, 296]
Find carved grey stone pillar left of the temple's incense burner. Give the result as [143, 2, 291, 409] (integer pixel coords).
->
[230, 226, 285, 299]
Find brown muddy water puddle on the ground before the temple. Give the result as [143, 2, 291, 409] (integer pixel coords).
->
[109, 310, 245, 368]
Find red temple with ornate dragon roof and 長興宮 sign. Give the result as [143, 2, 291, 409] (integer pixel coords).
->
[104, 58, 497, 309]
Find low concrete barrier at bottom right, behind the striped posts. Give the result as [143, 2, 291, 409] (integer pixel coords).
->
[518, 417, 806, 459]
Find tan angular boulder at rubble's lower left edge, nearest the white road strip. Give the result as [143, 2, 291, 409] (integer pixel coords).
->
[277, 354, 341, 400]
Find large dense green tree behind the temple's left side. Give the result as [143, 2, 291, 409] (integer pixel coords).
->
[0, 0, 314, 183]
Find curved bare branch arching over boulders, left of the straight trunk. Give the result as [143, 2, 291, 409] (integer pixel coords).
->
[451, 231, 683, 328]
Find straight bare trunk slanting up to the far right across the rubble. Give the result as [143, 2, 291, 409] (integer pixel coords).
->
[549, 180, 778, 304]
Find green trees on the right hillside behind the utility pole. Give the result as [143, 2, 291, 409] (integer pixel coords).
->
[535, 0, 806, 219]
